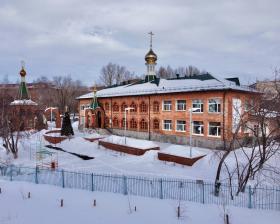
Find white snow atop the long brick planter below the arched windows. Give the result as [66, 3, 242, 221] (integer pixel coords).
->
[102, 135, 158, 150]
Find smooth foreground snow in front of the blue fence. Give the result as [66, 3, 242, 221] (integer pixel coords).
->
[0, 180, 280, 224]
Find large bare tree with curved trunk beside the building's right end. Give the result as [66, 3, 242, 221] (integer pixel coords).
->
[215, 73, 280, 195]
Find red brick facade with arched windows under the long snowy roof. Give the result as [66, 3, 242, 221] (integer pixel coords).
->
[79, 90, 253, 140]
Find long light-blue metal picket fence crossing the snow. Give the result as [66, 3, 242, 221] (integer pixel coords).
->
[0, 165, 280, 210]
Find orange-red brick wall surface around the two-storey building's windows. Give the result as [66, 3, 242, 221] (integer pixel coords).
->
[79, 91, 253, 142]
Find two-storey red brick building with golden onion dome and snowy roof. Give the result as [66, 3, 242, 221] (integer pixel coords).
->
[78, 33, 256, 148]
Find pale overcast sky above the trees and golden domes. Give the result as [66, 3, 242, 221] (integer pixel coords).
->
[0, 0, 280, 84]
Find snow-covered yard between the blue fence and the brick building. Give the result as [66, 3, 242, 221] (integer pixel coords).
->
[0, 122, 280, 184]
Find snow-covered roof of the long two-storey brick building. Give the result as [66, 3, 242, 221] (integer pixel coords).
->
[77, 75, 256, 99]
